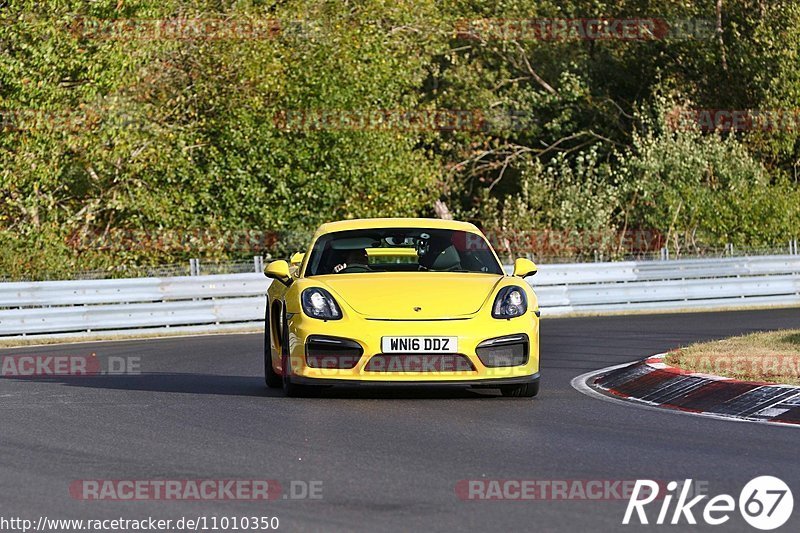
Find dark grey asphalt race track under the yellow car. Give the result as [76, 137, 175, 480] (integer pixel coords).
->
[0, 309, 800, 531]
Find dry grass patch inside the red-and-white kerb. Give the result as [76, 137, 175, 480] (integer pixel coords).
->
[664, 329, 800, 385]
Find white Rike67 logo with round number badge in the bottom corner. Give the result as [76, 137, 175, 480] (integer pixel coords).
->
[622, 476, 794, 531]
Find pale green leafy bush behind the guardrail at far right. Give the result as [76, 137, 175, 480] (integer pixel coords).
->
[619, 102, 800, 250]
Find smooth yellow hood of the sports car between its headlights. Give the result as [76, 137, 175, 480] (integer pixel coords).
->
[318, 272, 503, 320]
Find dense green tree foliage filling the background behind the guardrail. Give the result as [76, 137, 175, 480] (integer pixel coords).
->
[0, 0, 800, 277]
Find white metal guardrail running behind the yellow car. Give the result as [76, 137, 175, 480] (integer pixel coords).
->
[0, 255, 800, 338]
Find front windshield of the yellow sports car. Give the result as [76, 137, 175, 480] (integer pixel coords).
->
[306, 228, 503, 276]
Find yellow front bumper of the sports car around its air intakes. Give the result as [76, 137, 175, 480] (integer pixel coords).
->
[289, 312, 539, 387]
